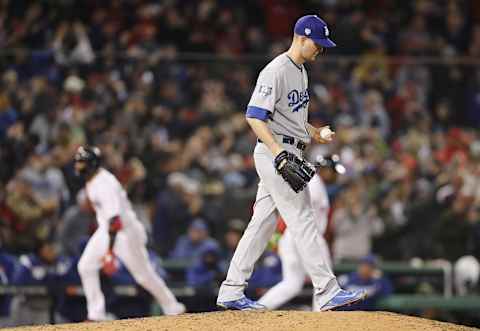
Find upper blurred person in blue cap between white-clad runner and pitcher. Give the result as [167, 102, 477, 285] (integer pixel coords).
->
[170, 218, 218, 260]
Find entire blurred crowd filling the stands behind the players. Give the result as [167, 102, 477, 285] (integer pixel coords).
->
[0, 0, 480, 326]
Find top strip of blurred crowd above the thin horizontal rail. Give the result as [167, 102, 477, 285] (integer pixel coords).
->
[0, 0, 480, 57]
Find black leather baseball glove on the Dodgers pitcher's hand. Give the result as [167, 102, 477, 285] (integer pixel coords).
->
[274, 151, 315, 193]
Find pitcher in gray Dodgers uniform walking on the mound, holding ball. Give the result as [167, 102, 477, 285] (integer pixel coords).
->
[217, 15, 364, 311]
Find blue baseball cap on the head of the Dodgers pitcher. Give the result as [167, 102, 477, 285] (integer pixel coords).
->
[293, 15, 337, 47]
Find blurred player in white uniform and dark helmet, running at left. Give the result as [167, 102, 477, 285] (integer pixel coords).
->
[75, 146, 185, 321]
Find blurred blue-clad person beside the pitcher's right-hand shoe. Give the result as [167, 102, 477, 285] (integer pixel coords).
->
[338, 255, 393, 310]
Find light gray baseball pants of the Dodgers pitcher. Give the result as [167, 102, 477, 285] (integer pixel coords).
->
[217, 143, 340, 307]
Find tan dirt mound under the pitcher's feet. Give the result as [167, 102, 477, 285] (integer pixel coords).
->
[4, 311, 478, 331]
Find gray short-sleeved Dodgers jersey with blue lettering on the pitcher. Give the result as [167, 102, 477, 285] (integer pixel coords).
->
[248, 53, 310, 144]
